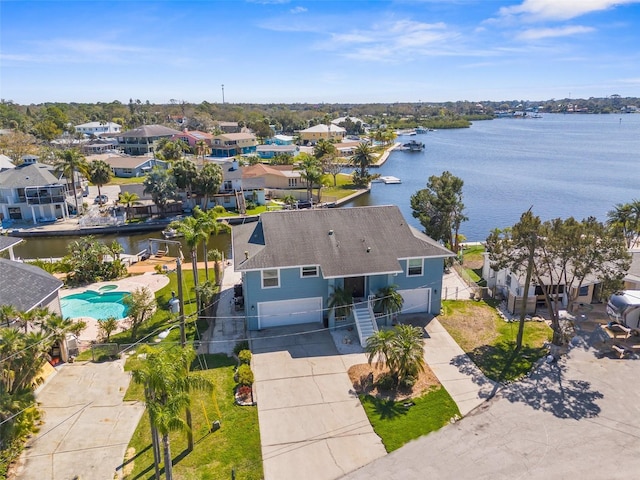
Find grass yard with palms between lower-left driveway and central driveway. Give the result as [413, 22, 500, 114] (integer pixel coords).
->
[124, 347, 263, 480]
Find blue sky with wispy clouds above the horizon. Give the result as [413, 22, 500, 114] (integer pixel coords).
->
[0, 0, 640, 104]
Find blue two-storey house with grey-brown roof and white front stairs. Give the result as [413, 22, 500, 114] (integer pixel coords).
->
[232, 206, 453, 341]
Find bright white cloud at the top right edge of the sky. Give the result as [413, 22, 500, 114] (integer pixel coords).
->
[499, 0, 640, 20]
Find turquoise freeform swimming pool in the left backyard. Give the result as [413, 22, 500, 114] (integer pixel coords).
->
[60, 290, 129, 320]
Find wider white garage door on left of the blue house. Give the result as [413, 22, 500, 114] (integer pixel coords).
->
[258, 297, 322, 329]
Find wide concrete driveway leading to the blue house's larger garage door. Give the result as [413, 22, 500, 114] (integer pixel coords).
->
[252, 324, 386, 480]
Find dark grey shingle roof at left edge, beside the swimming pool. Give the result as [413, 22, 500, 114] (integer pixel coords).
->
[0, 258, 62, 312]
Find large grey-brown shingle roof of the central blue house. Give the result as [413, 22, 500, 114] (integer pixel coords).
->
[232, 206, 452, 278]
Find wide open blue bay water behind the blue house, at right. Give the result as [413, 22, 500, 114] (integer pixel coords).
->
[350, 114, 640, 241]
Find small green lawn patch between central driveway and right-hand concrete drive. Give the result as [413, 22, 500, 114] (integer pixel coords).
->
[360, 387, 460, 452]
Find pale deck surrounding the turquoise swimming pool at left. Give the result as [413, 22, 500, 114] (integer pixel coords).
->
[60, 267, 169, 343]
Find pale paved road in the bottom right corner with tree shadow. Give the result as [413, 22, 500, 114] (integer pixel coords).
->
[343, 348, 640, 480]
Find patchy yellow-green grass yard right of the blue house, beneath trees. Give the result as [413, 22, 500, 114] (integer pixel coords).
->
[438, 300, 552, 382]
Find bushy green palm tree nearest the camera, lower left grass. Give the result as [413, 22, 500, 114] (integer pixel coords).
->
[132, 347, 213, 480]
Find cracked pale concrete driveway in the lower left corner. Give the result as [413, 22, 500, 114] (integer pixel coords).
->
[17, 360, 144, 480]
